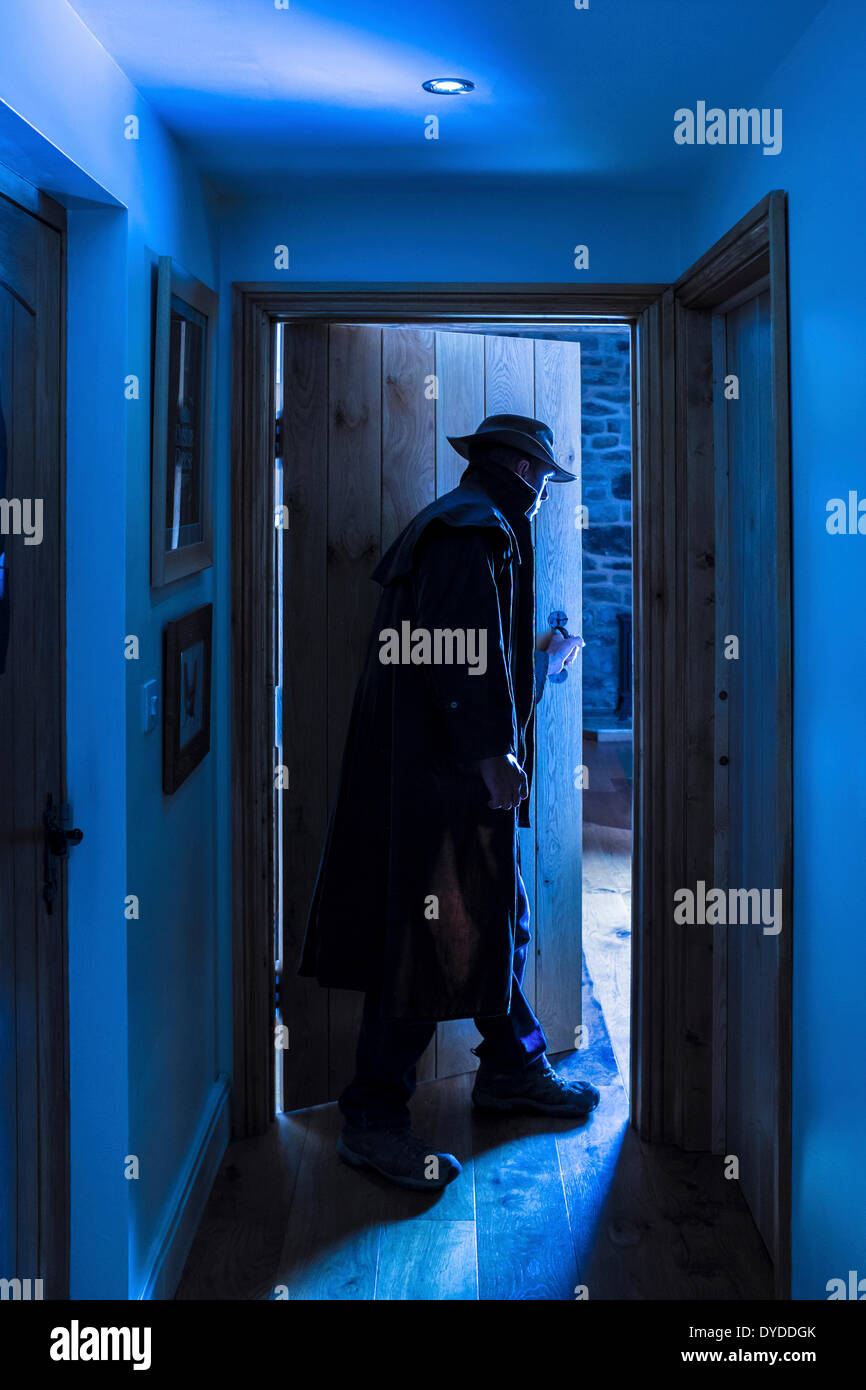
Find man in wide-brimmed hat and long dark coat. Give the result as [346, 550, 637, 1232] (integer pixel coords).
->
[300, 416, 598, 1188]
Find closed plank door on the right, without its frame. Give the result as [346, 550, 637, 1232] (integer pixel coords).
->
[713, 282, 791, 1278]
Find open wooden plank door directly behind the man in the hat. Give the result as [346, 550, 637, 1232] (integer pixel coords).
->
[279, 322, 582, 1109]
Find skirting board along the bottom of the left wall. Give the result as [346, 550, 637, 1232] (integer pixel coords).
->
[133, 1073, 231, 1300]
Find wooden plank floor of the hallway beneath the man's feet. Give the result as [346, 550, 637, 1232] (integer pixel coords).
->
[177, 956, 771, 1300]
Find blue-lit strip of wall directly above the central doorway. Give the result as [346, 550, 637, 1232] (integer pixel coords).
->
[221, 175, 681, 285]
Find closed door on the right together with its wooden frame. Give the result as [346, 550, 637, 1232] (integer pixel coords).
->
[632, 192, 794, 1298]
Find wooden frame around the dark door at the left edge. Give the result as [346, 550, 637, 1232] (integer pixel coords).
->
[0, 163, 71, 1300]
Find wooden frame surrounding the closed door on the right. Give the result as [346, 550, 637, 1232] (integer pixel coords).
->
[631, 192, 794, 1298]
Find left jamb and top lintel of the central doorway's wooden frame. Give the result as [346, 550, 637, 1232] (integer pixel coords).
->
[231, 284, 664, 1137]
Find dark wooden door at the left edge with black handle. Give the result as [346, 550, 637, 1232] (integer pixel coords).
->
[0, 179, 70, 1298]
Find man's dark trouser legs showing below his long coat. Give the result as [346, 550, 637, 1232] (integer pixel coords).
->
[338, 873, 548, 1129]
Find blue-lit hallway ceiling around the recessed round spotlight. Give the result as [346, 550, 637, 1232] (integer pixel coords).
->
[72, 0, 823, 193]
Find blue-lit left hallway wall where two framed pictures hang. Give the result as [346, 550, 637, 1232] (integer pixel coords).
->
[0, 0, 231, 1298]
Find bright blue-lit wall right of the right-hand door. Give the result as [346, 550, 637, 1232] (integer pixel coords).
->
[683, 0, 866, 1298]
